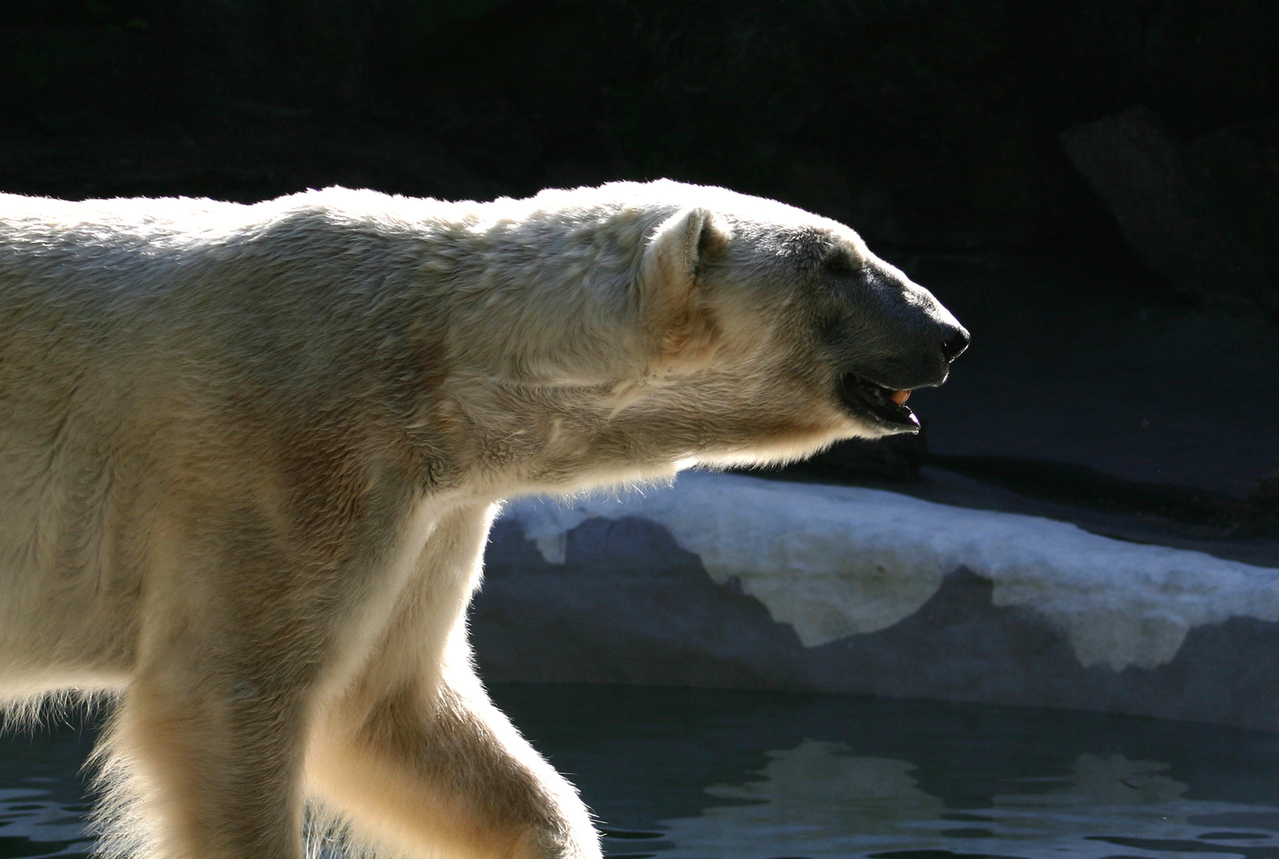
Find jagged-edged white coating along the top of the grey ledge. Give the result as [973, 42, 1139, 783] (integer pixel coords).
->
[504, 472, 1279, 671]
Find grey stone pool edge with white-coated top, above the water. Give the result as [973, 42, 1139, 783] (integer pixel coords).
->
[472, 473, 1279, 730]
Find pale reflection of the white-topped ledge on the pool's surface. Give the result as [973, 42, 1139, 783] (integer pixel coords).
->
[660, 740, 1258, 859]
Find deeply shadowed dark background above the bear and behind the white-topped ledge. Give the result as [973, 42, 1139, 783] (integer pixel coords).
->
[0, 0, 1279, 562]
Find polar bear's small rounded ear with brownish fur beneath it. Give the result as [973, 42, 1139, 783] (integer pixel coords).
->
[640, 207, 732, 371]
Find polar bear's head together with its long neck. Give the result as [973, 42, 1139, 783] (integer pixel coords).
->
[435, 182, 968, 487]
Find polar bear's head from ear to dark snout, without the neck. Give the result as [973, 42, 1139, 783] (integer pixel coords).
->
[640, 183, 968, 461]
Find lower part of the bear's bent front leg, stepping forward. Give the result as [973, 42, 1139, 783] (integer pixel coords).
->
[307, 667, 601, 859]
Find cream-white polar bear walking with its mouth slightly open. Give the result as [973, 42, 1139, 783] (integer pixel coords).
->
[0, 182, 968, 859]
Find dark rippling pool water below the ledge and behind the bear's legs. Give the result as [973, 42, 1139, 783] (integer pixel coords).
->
[0, 685, 1279, 859]
